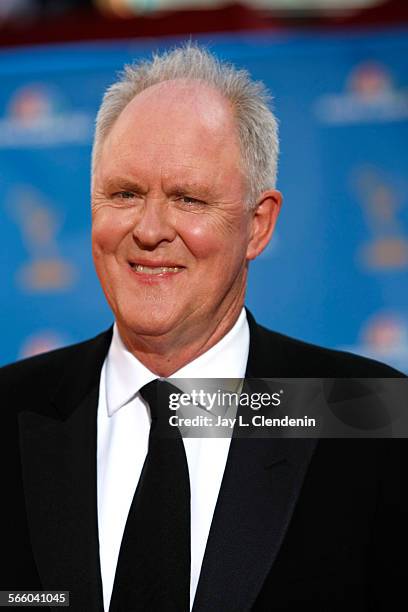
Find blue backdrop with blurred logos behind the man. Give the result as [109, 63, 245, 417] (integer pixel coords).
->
[0, 29, 408, 371]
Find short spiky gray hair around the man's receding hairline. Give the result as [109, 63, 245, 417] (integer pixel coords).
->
[92, 43, 279, 207]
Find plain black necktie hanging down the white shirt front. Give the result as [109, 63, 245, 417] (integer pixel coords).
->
[109, 380, 190, 612]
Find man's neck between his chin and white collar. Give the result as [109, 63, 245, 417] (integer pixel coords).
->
[117, 296, 244, 378]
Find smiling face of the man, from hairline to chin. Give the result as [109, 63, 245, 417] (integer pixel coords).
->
[92, 80, 270, 344]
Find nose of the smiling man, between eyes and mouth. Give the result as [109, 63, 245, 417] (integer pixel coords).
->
[132, 198, 176, 250]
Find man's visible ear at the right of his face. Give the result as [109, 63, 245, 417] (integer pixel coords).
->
[247, 189, 282, 260]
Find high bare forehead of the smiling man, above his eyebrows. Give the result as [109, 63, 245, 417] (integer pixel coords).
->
[98, 79, 240, 186]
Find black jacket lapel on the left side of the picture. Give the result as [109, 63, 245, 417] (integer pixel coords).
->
[19, 333, 110, 612]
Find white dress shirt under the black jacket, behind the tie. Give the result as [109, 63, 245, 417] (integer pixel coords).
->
[97, 309, 249, 612]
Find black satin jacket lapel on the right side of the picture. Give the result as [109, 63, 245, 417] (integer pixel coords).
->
[193, 315, 316, 612]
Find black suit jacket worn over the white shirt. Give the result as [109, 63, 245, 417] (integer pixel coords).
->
[0, 314, 408, 612]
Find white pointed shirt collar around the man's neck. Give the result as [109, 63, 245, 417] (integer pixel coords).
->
[105, 308, 249, 416]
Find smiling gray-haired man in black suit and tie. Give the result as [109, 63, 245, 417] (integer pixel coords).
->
[0, 45, 407, 612]
